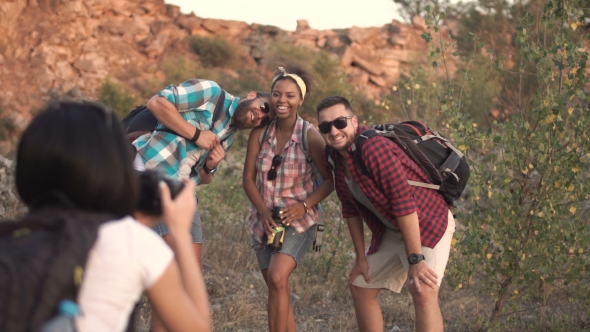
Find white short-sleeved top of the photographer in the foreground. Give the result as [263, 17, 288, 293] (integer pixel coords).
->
[76, 217, 173, 332]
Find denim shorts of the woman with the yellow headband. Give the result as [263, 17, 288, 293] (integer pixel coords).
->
[252, 225, 317, 270]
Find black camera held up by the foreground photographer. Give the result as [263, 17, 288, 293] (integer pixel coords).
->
[137, 169, 184, 216]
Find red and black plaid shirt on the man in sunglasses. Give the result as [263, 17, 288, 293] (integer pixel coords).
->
[324, 126, 448, 254]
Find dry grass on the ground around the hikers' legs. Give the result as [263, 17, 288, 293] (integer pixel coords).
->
[0, 154, 590, 331]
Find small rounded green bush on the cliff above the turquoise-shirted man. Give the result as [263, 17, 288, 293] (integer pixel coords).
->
[188, 36, 239, 68]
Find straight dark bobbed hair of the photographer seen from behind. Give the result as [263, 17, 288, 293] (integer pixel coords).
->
[16, 102, 137, 217]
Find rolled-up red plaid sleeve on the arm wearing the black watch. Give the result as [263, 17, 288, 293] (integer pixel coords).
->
[362, 137, 418, 217]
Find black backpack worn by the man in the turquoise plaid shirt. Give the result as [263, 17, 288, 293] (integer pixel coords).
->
[121, 90, 225, 141]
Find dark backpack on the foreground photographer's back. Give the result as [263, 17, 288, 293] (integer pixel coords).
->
[0, 209, 114, 332]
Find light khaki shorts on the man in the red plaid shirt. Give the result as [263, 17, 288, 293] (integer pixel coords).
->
[352, 211, 455, 293]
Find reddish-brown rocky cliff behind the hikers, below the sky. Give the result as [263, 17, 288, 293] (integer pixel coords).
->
[0, 0, 458, 150]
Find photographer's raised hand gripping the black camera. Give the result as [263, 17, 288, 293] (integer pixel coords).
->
[160, 181, 197, 234]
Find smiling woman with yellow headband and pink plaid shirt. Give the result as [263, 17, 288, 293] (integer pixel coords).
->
[243, 67, 334, 332]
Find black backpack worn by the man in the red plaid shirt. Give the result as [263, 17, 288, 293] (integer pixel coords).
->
[328, 121, 471, 206]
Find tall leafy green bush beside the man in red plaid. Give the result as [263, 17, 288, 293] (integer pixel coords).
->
[423, 0, 590, 331]
